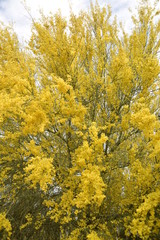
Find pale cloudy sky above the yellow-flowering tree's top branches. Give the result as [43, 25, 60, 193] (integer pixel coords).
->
[0, 0, 141, 41]
